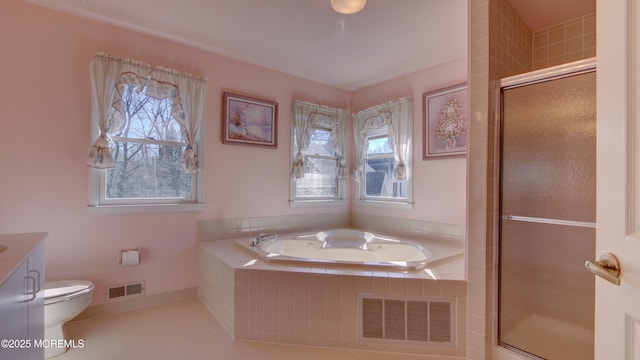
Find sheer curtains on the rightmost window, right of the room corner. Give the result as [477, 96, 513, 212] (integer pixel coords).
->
[353, 98, 413, 181]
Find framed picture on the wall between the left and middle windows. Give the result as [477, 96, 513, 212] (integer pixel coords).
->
[222, 92, 278, 148]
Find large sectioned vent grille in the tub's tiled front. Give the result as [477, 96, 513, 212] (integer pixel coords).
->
[358, 295, 456, 347]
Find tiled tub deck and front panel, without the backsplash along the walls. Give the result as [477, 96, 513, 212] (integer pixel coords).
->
[198, 233, 467, 358]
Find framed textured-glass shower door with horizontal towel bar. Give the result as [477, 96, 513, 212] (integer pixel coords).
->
[498, 60, 596, 360]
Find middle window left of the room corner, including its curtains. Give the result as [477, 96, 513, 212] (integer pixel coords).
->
[291, 101, 347, 205]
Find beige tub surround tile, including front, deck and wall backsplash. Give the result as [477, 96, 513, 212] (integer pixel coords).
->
[198, 212, 466, 357]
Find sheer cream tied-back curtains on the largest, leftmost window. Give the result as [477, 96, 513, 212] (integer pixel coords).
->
[87, 53, 207, 174]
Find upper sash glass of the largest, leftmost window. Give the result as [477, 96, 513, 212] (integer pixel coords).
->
[115, 85, 183, 142]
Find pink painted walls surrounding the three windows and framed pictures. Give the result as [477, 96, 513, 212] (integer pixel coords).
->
[0, 0, 466, 303]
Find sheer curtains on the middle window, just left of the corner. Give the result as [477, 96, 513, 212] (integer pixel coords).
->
[291, 101, 347, 179]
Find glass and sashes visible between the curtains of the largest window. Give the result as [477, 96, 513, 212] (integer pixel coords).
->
[100, 85, 196, 204]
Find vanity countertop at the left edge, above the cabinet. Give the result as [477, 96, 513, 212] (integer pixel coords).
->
[0, 233, 47, 284]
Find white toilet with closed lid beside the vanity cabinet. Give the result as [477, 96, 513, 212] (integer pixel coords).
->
[44, 280, 94, 359]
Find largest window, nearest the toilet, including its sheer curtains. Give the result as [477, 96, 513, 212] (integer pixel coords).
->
[88, 54, 206, 211]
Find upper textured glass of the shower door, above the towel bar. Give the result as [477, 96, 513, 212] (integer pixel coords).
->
[502, 73, 596, 222]
